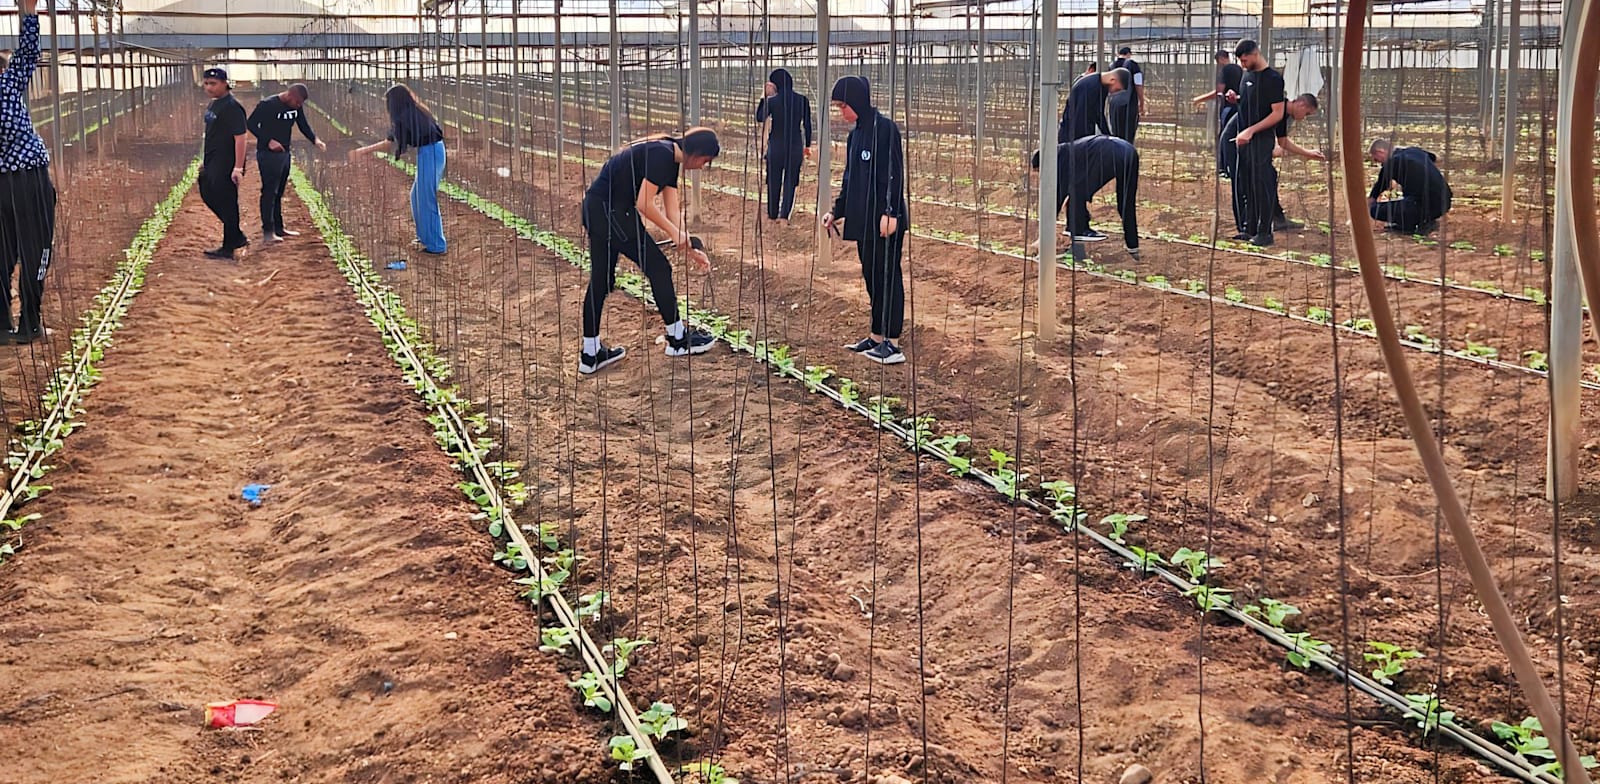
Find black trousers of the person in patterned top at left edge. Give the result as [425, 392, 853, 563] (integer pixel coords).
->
[0, 168, 56, 333]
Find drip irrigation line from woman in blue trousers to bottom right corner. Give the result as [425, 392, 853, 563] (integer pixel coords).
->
[386, 132, 1560, 784]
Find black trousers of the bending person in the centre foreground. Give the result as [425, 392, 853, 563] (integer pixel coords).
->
[584, 198, 678, 338]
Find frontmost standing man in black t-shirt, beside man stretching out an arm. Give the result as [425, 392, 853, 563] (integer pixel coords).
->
[1230, 38, 1285, 248]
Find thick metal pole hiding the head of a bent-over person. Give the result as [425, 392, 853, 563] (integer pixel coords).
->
[1038, 0, 1062, 347]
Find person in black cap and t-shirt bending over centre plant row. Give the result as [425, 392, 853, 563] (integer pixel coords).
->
[578, 128, 722, 374]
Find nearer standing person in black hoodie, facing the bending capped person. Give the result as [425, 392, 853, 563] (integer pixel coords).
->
[822, 77, 910, 365]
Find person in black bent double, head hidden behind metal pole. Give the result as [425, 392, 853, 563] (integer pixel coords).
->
[1032, 136, 1139, 259]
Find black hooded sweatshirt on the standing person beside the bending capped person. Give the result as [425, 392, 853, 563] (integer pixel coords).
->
[829, 77, 910, 242]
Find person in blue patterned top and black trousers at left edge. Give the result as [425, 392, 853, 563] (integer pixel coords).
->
[0, 0, 56, 342]
